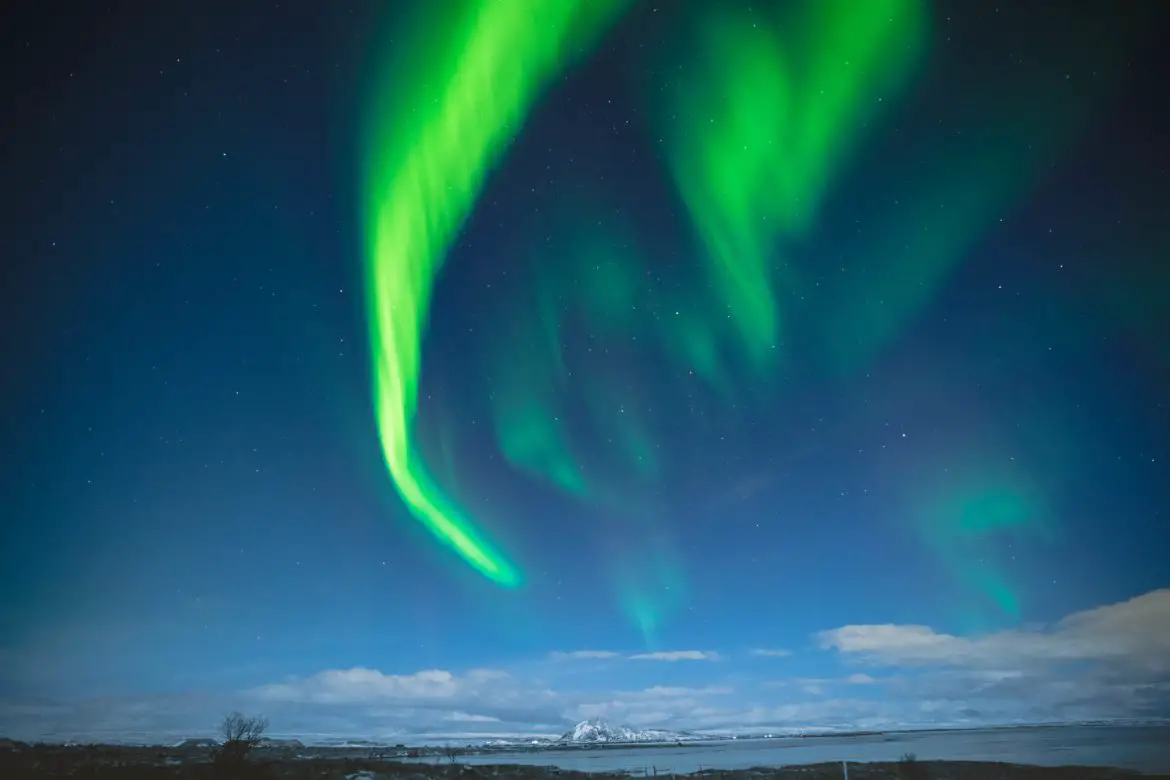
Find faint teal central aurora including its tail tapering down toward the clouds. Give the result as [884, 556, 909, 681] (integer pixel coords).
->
[486, 204, 687, 649]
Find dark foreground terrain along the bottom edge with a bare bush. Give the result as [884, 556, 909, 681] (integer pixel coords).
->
[0, 745, 1170, 780]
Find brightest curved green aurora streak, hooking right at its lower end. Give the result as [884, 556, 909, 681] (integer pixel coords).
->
[363, 0, 625, 586]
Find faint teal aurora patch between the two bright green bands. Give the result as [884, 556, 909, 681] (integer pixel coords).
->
[488, 210, 658, 505]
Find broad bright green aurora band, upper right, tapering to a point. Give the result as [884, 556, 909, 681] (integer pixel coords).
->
[658, 0, 927, 375]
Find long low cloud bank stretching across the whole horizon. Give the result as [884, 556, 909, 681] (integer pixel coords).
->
[0, 591, 1170, 743]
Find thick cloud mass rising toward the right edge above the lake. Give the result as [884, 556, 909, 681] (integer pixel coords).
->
[817, 589, 1170, 722]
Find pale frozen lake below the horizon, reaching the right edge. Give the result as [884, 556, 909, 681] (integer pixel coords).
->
[439, 726, 1170, 773]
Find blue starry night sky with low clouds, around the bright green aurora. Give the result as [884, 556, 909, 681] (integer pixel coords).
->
[0, 1, 1170, 738]
